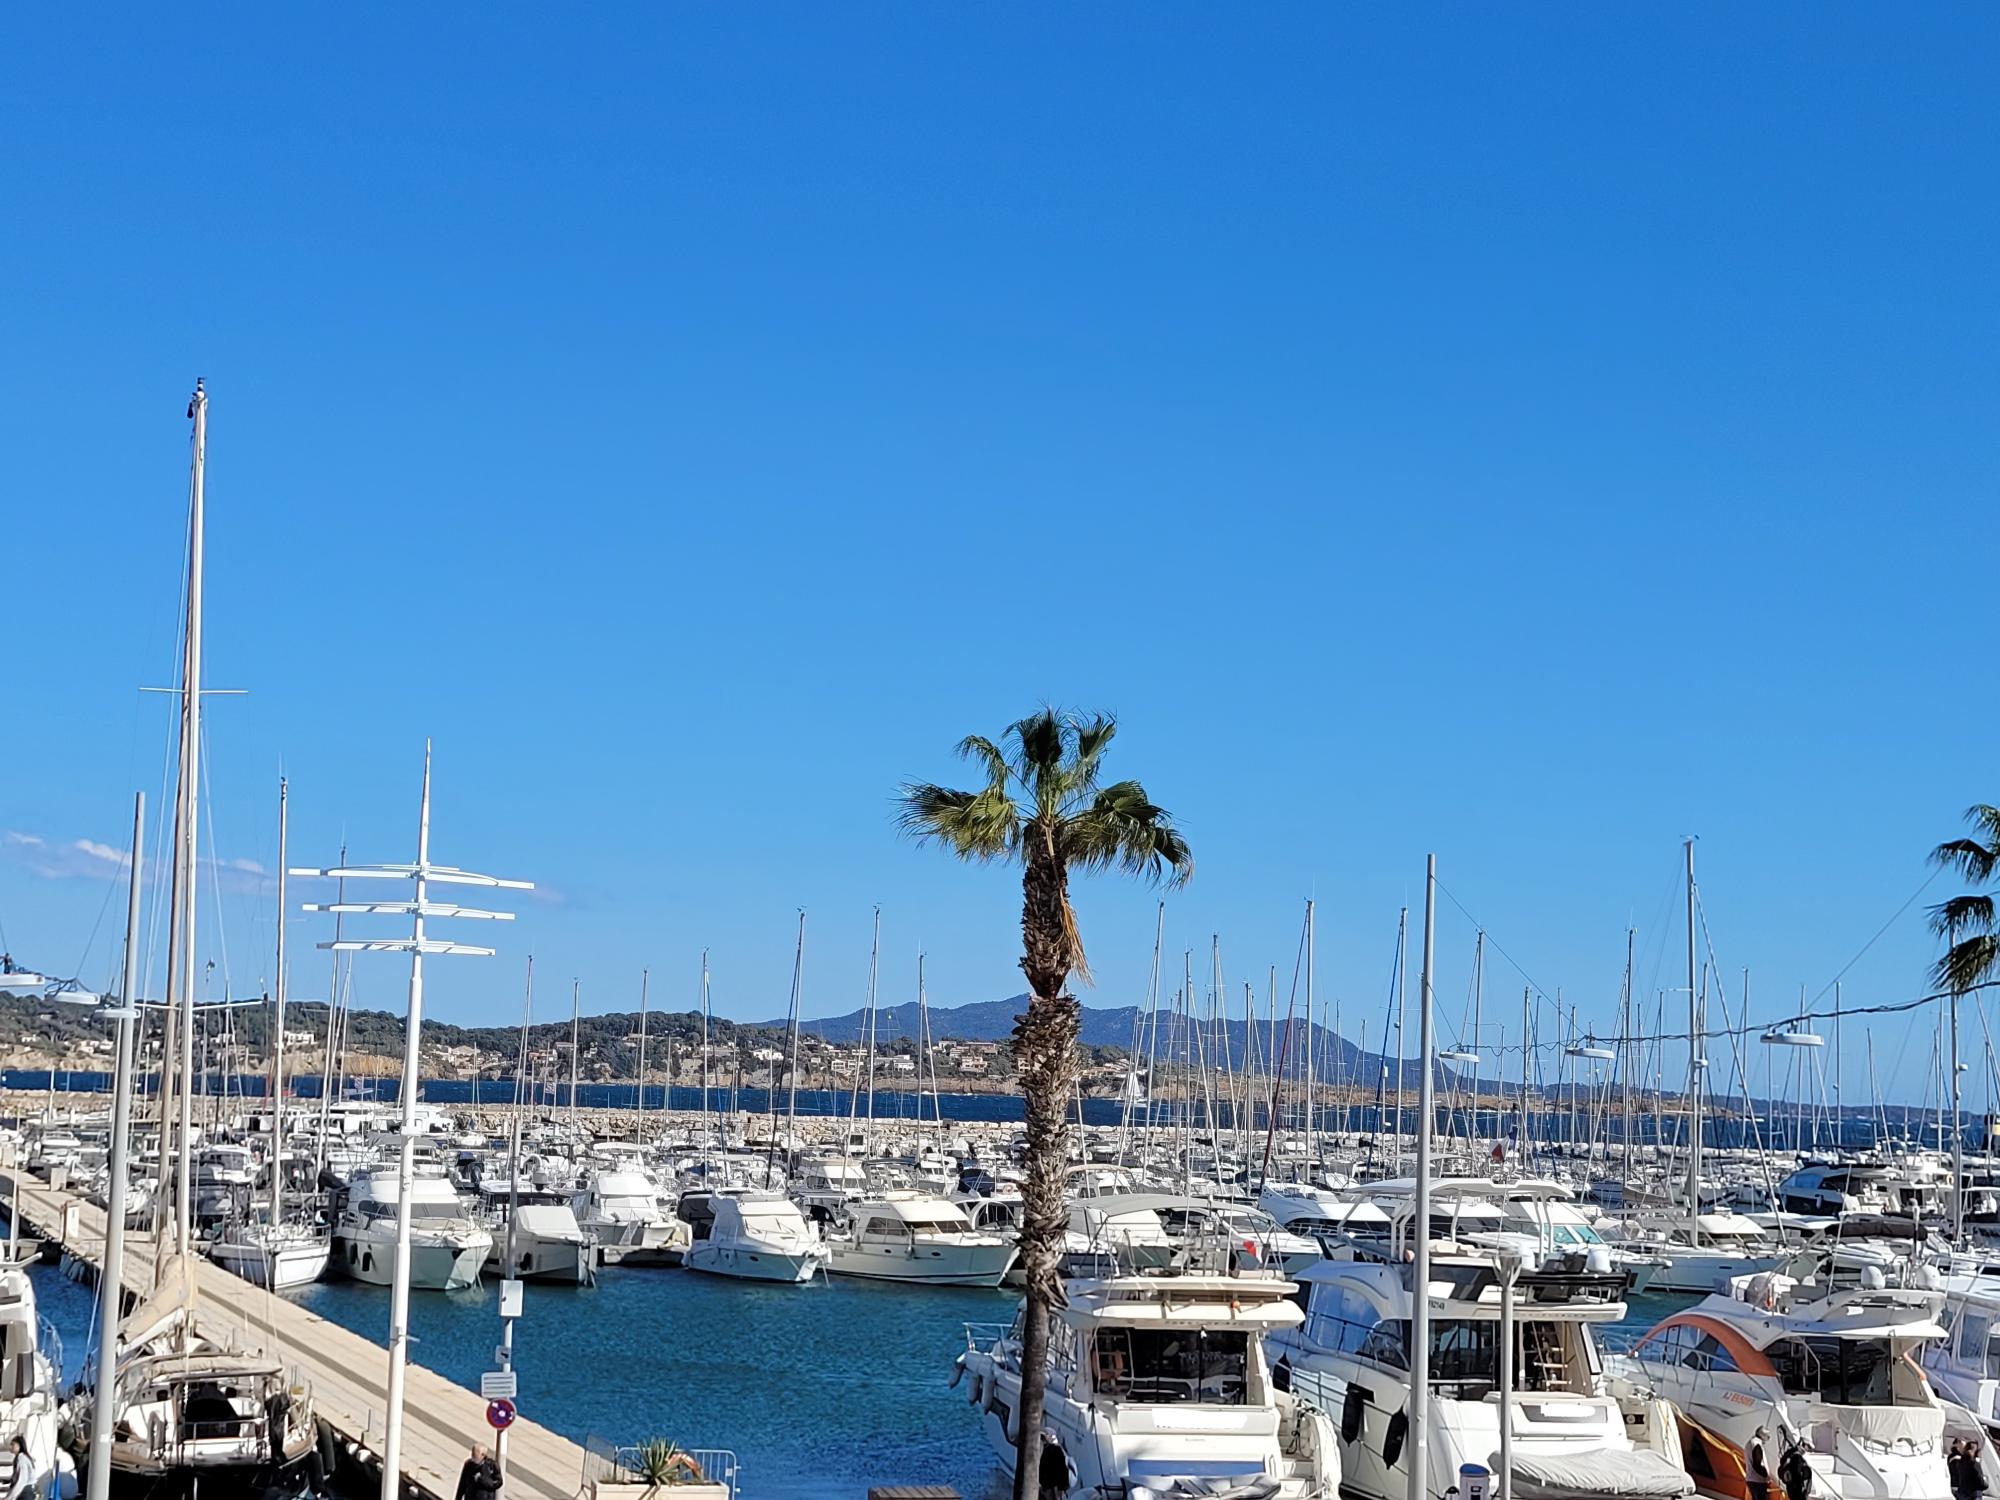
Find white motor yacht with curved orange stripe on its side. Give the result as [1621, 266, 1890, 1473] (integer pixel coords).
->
[1614, 1272, 1952, 1500]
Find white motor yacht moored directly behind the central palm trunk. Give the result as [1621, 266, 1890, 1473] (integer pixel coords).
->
[954, 1274, 1340, 1500]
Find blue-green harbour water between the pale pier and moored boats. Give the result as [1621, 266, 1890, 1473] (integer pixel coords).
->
[15, 1266, 1690, 1500]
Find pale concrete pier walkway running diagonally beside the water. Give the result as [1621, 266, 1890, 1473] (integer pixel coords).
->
[0, 1168, 590, 1500]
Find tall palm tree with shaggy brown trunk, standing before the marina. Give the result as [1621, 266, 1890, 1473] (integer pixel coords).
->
[898, 708, 1194, 1500]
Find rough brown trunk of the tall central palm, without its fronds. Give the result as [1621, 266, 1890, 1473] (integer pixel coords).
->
[1014, 852, 1080, 1500]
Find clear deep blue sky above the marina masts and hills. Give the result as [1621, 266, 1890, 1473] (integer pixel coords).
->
[0, 6, 2000, 1096]
